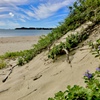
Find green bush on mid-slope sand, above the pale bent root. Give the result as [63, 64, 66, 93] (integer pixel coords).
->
[48, 33, 88, 59]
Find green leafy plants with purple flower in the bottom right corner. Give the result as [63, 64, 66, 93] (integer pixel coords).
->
[48, 67, 100, 100]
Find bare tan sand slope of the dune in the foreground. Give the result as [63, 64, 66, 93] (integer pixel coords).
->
[0, 23, 100, 100]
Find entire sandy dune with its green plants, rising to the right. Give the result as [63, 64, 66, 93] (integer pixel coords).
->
[0, 0, 100, 100]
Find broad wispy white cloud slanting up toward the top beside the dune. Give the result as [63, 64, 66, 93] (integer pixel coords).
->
[26, 0, 75, 19]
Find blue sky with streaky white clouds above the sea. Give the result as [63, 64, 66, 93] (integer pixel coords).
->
[0, 0, 75, 29]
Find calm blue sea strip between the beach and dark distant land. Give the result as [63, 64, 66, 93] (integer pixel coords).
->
[0, 29, 51, 37]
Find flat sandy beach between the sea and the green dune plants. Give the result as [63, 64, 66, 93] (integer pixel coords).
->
[0, 36, 39, 55]
